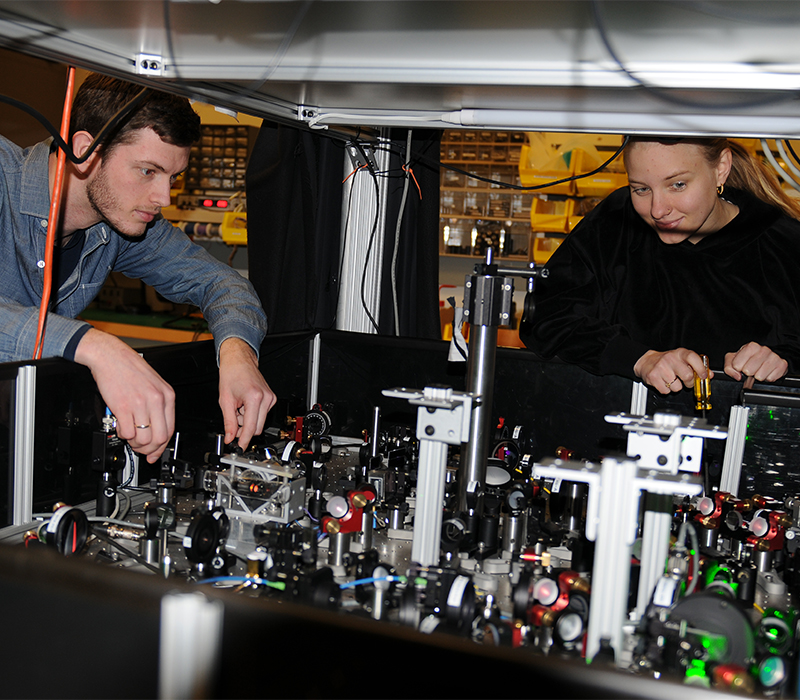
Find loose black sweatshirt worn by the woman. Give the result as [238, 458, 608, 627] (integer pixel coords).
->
[520, 188, 800, 379]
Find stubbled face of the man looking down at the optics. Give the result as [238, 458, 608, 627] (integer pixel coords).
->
[86, 129, 189, 236]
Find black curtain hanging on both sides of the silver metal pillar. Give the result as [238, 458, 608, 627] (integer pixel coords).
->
[247, 121, 440, 338]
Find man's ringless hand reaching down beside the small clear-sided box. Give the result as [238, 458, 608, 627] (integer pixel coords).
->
[219, 338, 275, 450]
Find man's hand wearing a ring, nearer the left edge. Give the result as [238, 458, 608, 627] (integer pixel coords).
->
[75, 328, 175, 464]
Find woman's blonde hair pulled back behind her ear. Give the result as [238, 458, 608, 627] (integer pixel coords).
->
[625, 136, 800, 220]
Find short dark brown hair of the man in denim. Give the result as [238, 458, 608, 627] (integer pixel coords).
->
[70, 73, 200, 156]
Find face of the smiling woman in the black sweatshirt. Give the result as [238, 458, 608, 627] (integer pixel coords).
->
[625, 141, 731, 243]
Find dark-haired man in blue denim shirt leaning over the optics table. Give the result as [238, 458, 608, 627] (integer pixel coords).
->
[0, 75, 275, 462]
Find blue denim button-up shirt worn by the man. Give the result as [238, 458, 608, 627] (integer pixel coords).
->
[0, 136, 267, 362]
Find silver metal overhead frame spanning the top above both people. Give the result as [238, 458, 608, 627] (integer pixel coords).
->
[0, 0, 800, 138]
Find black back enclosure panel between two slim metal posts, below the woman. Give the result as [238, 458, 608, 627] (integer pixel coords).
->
[310, 331, 742, 460]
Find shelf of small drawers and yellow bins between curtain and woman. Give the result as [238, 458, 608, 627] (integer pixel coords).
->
[439, 131, 612, 263]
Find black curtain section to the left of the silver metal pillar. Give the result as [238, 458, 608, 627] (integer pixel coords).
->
[246, 121, 344, 333]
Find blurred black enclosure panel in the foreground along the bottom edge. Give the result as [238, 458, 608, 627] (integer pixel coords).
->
[0, 545, 706, 699]
